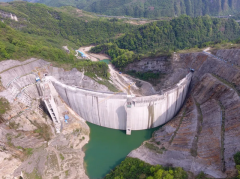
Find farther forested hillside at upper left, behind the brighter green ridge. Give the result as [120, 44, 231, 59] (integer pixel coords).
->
[0, 2, 134, 46]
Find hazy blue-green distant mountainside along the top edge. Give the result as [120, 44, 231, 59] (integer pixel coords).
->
[16, 0, 240, 18]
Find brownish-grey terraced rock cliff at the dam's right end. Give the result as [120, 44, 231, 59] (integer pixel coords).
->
[129, 49, 240, 178]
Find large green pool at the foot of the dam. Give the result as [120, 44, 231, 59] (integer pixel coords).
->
[84, 123, 157, 179]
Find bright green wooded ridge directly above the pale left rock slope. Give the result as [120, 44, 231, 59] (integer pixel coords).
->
[0, 21, 108, 79]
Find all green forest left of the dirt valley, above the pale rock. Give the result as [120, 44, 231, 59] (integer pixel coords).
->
[0, 2, 135, 78]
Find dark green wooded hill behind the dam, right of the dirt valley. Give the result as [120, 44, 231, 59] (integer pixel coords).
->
[92, 15, 240, 67]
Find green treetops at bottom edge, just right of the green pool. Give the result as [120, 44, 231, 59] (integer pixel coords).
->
[105, 157, 188, 179]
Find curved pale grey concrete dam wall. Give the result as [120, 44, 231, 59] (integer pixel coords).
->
[51, 73, 192, 131]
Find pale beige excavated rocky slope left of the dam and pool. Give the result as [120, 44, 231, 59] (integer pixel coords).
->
[0, 59, 95, 179]
